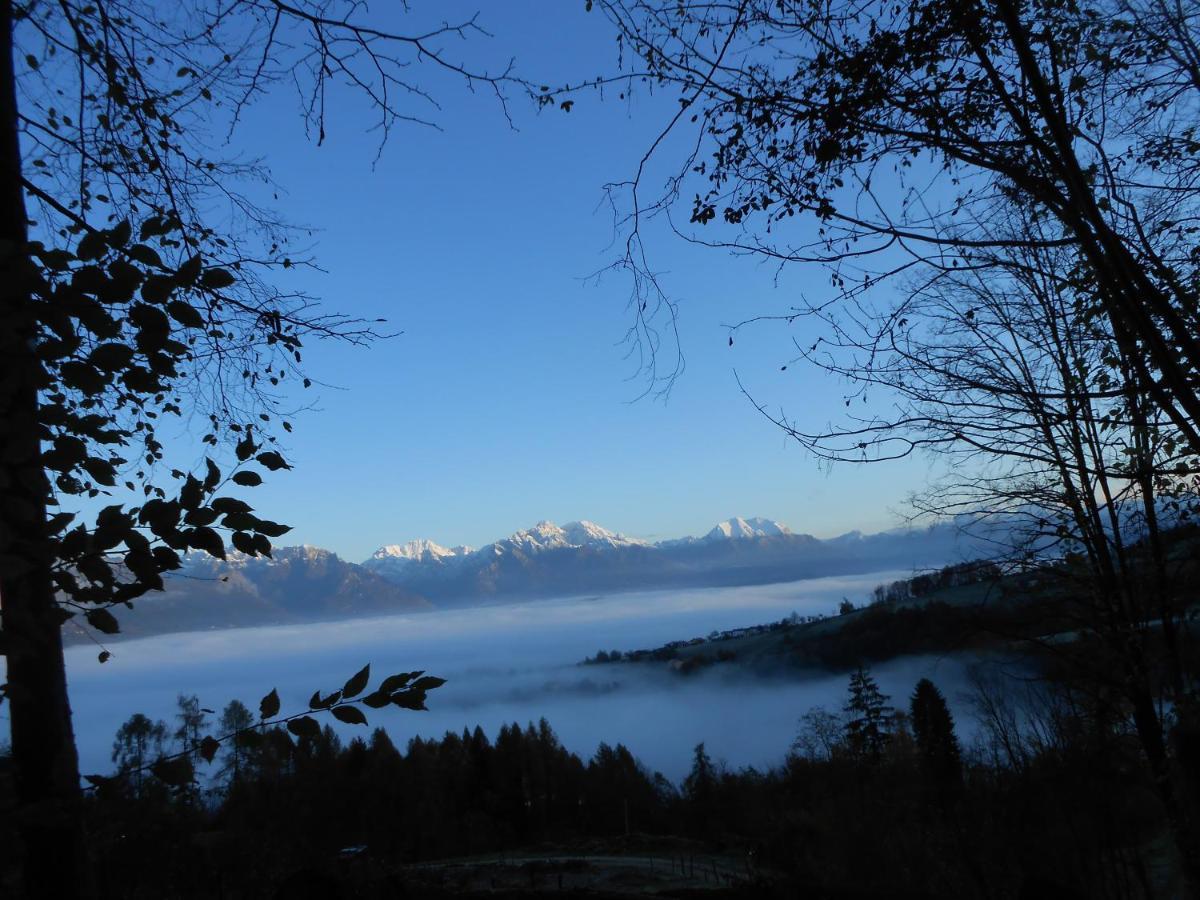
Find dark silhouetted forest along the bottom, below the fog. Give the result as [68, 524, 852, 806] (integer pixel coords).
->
[0, 667, 1180, 898]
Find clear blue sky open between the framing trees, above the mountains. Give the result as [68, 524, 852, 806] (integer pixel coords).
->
[164, 2, 926, 559]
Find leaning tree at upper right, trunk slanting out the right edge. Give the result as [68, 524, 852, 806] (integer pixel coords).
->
[596, 0, 1200, 452]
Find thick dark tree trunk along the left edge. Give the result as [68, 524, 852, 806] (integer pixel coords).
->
[0, 0, 92, 899]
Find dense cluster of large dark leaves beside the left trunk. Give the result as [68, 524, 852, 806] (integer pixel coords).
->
[19, 217, 300, 632]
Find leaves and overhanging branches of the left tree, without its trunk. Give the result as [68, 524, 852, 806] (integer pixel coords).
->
[9, 0, 595, 648]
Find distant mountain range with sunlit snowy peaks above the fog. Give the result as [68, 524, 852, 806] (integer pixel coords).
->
[79, 518, 979, 642]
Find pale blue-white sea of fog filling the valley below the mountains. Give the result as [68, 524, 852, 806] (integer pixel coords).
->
[67, 572, 964, 781]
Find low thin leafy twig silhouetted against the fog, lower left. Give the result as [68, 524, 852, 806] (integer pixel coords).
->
[84, 664, 445, 788]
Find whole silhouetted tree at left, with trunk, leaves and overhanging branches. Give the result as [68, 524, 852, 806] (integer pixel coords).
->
[0, 0, 528, 896]
